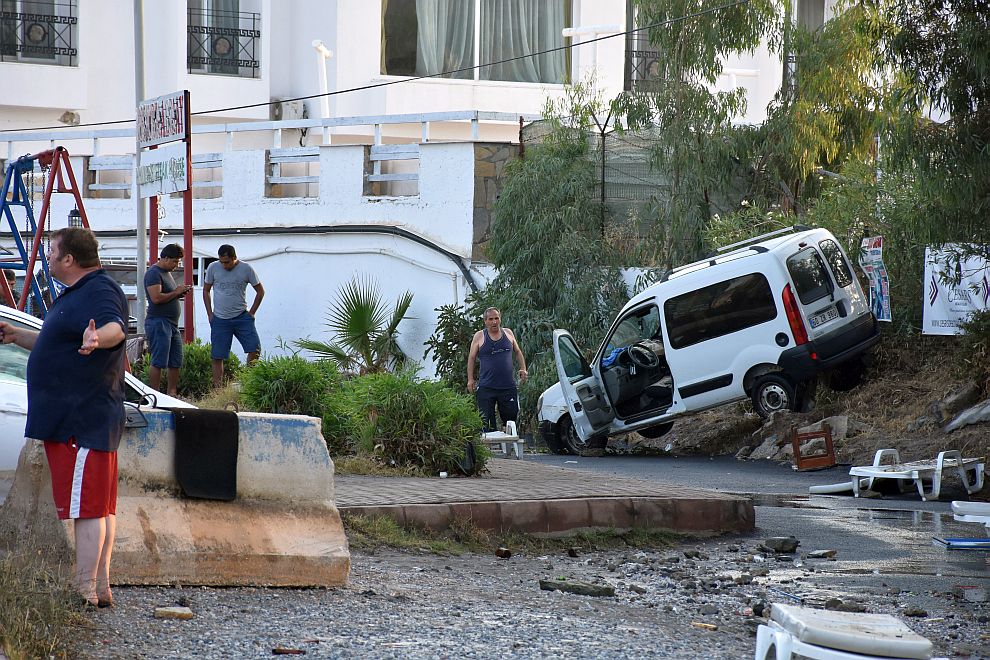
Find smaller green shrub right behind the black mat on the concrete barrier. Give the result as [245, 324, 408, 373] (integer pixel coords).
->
[238, 355, 340, 418]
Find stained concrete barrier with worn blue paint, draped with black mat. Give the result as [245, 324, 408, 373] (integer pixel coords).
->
[0, 409, 350, 586]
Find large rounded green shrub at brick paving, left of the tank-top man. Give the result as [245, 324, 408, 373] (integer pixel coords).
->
[340, 372, 490, 474]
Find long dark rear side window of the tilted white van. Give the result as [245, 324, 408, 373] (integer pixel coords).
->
[663, 273, 777, 348]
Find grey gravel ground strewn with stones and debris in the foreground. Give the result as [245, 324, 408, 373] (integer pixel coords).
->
[77, 535, 990, 659]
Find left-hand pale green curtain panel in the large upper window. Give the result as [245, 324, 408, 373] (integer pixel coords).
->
[416, 0, 474, 78]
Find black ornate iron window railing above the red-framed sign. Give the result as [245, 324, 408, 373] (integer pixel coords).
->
[186, 8, 261, 78]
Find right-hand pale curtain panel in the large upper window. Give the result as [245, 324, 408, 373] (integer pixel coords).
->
[480, 0, 567, 83]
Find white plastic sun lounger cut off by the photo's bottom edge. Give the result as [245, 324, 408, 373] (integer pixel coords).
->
[754, 603, 932, 660]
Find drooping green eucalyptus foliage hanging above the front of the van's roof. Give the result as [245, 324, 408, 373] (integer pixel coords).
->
[620, 0, 782, 266]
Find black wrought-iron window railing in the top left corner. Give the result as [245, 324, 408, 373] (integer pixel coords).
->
[0, 0, 79, 66]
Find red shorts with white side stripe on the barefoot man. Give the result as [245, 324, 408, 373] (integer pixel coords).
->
[45, 438, 117, 520]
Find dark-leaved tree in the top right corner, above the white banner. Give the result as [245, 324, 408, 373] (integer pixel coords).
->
[883, 0, 990, 248]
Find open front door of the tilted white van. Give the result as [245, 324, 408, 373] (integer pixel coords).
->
[553, 330, 615, 442]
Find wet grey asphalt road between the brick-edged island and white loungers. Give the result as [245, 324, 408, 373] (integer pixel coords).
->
[526, 455, 990, 591]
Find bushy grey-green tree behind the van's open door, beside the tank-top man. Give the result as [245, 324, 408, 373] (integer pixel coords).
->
[486, 85, 628, 420]
